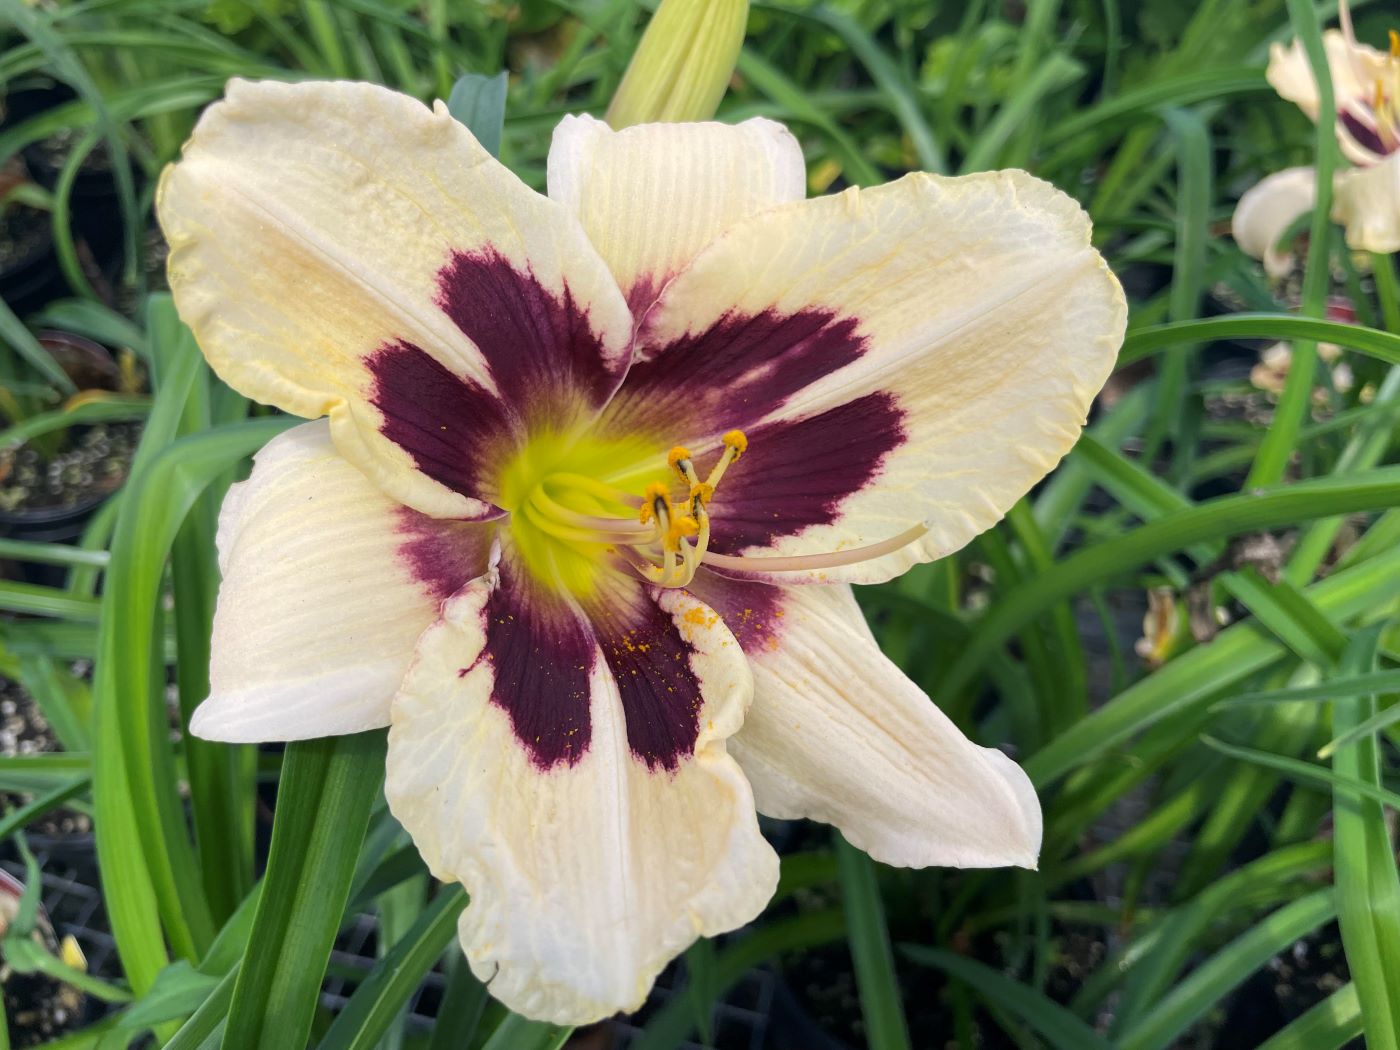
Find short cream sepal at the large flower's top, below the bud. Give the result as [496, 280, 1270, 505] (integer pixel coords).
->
[549, 116, 806, 316]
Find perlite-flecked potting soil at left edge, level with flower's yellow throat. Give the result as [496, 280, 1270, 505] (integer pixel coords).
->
[0, 421, 140, 514]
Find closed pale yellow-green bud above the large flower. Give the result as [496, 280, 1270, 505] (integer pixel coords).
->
[608, 0, 749, 129]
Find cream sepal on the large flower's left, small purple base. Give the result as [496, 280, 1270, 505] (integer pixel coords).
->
[190, 420, 491, 742]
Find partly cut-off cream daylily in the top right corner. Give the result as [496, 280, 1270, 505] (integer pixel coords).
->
[1233, 3, 1400, 267]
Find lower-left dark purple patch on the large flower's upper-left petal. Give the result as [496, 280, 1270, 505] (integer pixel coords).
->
[365, 343, 510, 500]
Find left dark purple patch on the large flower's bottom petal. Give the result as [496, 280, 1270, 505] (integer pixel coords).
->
[468, 563, 598, 771]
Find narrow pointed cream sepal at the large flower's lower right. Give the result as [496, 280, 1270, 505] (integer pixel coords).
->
[697, 578, 1042, 868]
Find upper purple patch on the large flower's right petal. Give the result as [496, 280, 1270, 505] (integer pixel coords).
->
[608, 309, 865, 438]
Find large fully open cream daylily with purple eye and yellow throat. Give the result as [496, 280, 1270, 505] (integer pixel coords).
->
[158, 81, 1126, 1023]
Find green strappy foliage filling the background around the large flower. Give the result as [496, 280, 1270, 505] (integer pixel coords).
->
[0, 0, 1400, 1050]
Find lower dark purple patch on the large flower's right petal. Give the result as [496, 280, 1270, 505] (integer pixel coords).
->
[710, 391, 907, 554]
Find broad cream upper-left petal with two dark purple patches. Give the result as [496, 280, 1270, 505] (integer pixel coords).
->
[157, 80, 631, 517]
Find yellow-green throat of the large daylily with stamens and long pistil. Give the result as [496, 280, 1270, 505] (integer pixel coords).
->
[498, 430, 928, 598]
